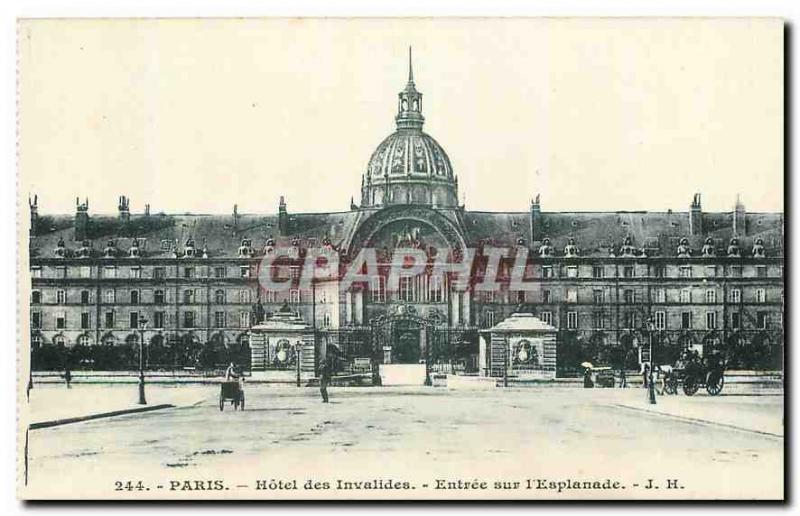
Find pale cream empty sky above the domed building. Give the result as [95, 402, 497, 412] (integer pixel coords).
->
[18, 18, 784, 214]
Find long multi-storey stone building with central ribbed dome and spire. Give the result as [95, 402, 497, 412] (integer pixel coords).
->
[30, 54, 784, 374]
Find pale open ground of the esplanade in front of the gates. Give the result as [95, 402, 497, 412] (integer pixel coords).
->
[23, 385, 783, 498]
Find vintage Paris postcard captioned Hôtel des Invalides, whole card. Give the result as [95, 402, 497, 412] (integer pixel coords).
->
[17, 18, 785, 500]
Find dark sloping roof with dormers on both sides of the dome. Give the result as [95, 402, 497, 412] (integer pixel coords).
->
[30, 210, 783, 258]
